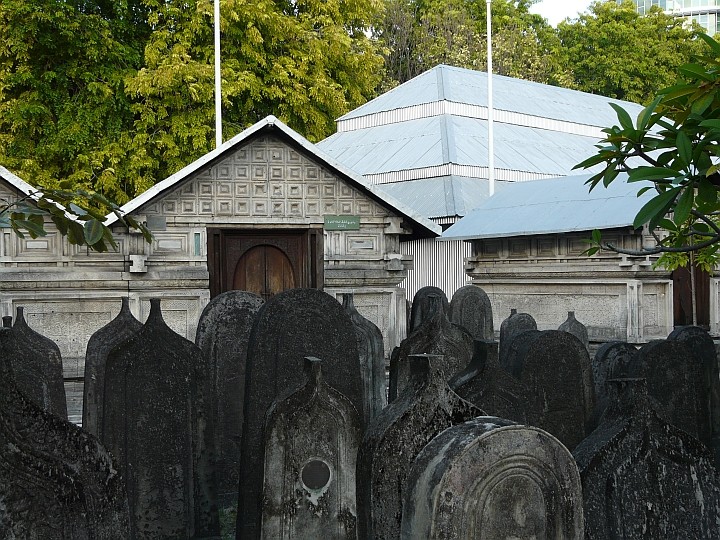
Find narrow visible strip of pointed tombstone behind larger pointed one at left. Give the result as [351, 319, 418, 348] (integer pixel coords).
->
[82, 296, 142, 437]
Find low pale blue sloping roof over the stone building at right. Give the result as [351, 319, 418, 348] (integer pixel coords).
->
[440, 174, 654, 240]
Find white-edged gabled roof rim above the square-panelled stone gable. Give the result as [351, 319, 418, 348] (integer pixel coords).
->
[105, 116, 440, 237]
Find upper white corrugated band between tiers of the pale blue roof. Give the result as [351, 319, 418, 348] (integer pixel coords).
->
[337, 101, 603, 139]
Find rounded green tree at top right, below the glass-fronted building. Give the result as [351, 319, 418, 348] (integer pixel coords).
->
[556, 0, 701, 104]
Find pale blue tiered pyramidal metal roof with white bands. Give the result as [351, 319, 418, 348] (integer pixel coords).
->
[318, 65, 642, 218]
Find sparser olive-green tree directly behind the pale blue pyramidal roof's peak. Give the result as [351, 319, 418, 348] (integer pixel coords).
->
[376, 0, 566, 88]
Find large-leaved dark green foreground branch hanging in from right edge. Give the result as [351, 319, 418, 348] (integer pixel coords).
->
[574, 34, 720, 270]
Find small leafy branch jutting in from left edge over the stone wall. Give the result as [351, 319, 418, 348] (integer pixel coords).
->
[0, 189, 152, 252]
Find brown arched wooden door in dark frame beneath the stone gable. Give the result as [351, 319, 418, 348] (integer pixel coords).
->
[208, 229, 323, 300]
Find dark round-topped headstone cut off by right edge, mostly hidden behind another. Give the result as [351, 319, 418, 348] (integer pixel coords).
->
[668, 326, 720, 467]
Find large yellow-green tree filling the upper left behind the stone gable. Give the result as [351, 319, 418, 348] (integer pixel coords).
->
[0, 0, 382, 203]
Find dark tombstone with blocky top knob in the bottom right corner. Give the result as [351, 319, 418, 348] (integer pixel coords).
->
[573, 379, 720, 540]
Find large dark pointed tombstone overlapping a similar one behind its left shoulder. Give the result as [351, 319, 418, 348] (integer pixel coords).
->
[101, 298, 219, 538]
